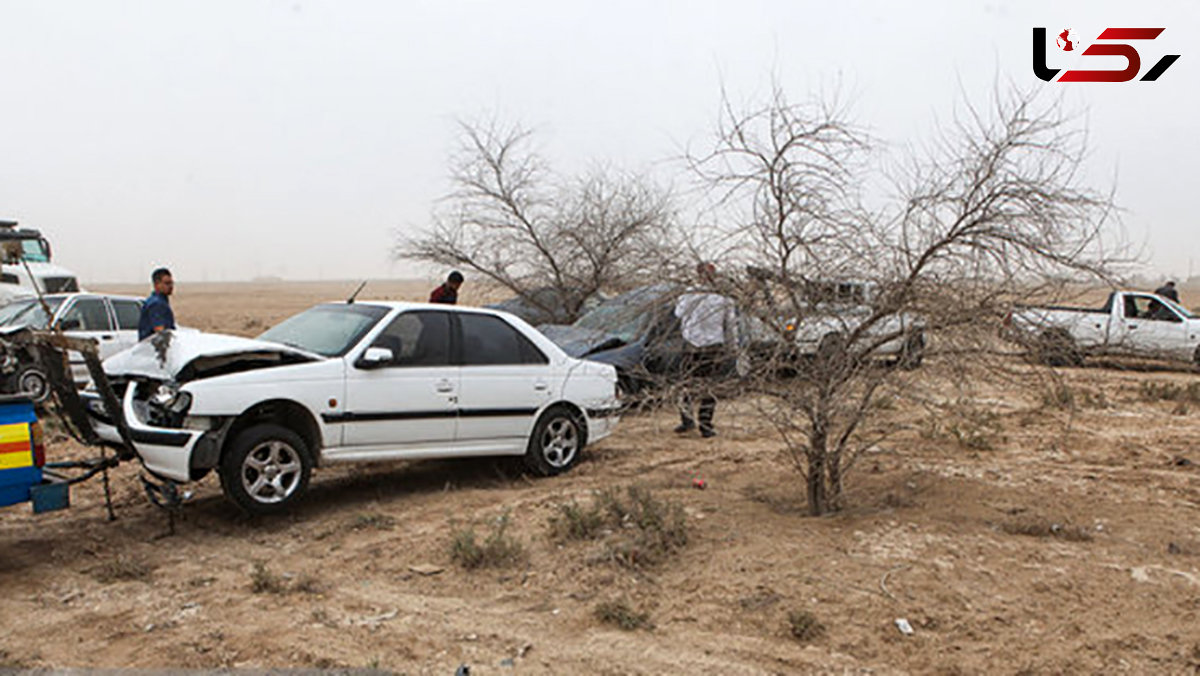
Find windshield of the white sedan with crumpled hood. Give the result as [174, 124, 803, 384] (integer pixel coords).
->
[258, 303, 388, 357]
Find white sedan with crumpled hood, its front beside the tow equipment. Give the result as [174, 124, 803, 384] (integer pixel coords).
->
[84, 301, 619, 514]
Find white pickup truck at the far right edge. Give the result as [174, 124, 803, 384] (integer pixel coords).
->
[1003, 291, 1200, 365]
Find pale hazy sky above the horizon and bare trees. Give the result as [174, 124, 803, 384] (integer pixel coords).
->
[0, 0, 1200, 283]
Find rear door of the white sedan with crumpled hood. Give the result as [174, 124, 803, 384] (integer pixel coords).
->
[455, 312, 552, 453]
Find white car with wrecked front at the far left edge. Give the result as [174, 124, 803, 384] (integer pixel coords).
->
[0, 293, 142, 405]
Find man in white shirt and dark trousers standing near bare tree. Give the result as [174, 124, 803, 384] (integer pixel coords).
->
[674, 263, 738, 438]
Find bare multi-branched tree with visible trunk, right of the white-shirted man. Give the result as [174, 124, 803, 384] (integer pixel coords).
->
[689, 89, 1116, 515]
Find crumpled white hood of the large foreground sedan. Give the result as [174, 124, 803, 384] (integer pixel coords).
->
[104, 330, 324, 381]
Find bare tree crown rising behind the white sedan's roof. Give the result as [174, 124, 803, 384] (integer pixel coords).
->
[395, 118, 673, 323]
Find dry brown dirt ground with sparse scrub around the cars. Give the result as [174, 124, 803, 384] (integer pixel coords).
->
[0, 283, 1200, 675]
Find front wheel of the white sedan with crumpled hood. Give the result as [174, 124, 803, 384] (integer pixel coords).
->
[220, 423, 312, 514]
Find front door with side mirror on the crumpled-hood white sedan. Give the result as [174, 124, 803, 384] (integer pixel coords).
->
[342, 310, 461, 453]
